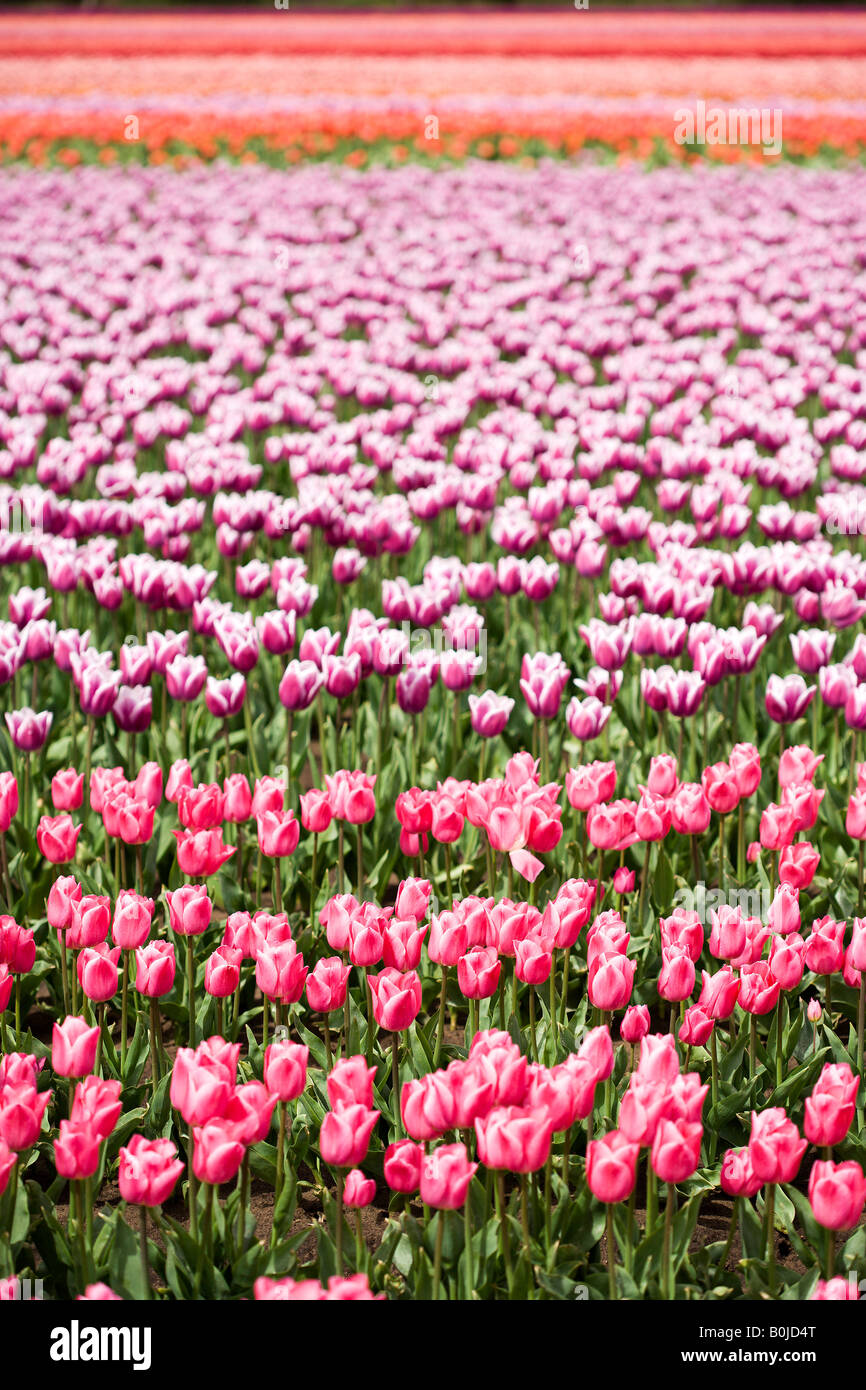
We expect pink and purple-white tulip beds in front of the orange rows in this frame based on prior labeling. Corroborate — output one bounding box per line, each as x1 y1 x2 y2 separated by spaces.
0 18 866 1319
